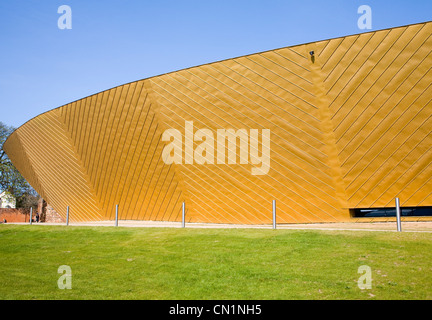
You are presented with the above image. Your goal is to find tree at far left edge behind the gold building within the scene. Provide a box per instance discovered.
[0,121,39,207]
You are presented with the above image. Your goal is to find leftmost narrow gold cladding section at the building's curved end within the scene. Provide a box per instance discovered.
[8,109,103,221]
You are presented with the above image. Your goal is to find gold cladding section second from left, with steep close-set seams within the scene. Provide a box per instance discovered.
[57,81,182,221]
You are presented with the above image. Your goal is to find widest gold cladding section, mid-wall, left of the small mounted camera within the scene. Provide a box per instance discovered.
[151,47,343,223]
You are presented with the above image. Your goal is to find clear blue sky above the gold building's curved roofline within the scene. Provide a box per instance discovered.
[0,0,432,127]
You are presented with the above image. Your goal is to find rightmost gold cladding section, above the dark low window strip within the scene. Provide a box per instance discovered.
[323,23,432,208]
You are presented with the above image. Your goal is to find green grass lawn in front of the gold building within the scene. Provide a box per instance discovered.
[0,224,432,300]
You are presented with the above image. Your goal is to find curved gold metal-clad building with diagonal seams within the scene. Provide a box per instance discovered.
[4,22,432,224]
